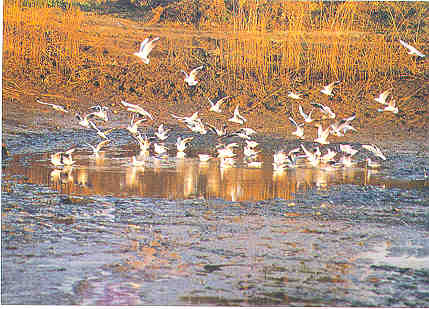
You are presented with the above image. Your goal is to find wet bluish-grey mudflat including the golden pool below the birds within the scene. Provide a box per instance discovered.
[2,127,429,307]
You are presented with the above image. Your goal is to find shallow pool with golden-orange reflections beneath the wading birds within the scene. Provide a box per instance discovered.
[3,148,429,201]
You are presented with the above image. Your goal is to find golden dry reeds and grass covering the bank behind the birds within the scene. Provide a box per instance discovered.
[3,0,428,132]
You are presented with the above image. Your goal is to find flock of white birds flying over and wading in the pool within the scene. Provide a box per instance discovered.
[37,37,425,179]
